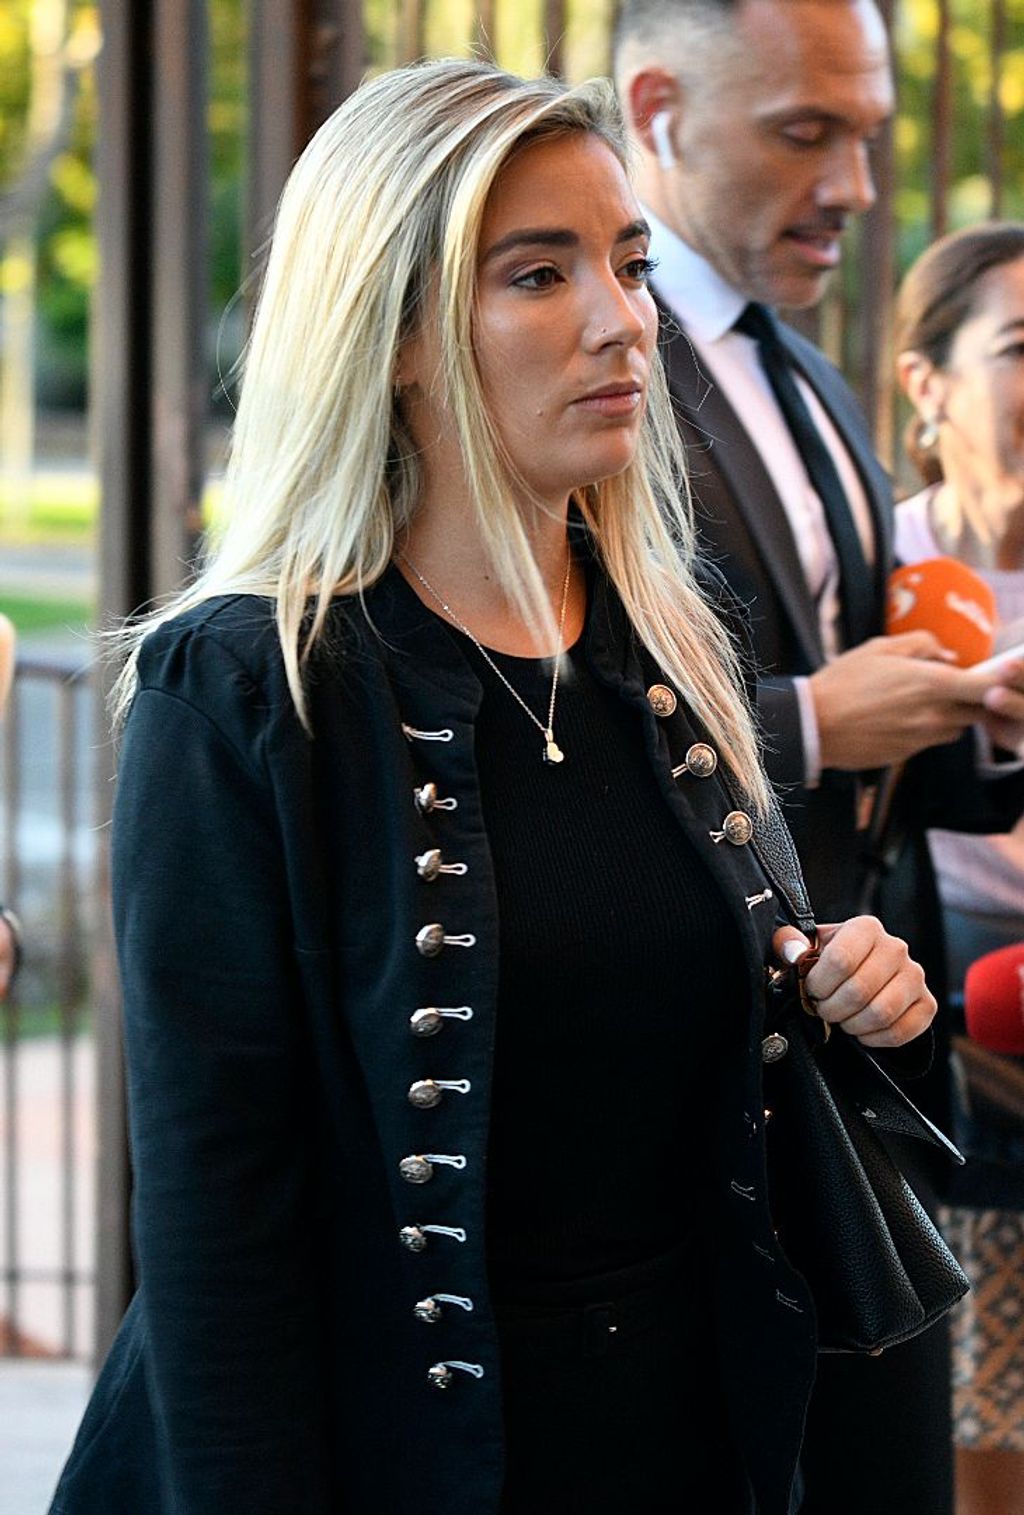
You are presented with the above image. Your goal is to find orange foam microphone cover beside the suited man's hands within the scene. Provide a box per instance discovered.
[885,558,997,668]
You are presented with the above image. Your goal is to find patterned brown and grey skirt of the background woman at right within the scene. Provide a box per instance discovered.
[942,1207,1024,1451]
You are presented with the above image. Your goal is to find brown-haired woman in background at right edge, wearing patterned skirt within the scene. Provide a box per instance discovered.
[897,223,1024,1515]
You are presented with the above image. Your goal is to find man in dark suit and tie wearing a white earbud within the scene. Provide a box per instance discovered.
[615,0,1024,1515]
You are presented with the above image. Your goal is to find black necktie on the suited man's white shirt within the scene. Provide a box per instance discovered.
[733,303,876,647]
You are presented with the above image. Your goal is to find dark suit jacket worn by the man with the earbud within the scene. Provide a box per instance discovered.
[662,311,1024,1030]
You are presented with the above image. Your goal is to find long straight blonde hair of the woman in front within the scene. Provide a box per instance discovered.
[115,59,768,806]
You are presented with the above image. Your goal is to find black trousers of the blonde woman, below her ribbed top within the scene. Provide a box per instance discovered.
[497,1260,753,1515]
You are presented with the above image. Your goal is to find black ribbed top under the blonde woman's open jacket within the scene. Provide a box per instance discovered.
[451,624,747,1297]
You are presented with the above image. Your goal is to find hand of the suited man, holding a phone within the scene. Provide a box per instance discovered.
[807,632,1024,770]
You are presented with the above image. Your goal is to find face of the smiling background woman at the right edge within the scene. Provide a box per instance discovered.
[941,258,1024,482]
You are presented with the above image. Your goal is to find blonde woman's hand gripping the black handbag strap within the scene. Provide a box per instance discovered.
[771,915,938,1047]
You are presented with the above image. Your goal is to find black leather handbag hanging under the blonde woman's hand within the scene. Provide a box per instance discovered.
[765,954,968,1353]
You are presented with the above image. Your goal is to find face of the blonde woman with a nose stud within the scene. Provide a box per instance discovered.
[400,132,657,508]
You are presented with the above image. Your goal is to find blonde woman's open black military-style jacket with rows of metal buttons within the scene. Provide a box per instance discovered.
[53,570,815,1515]
